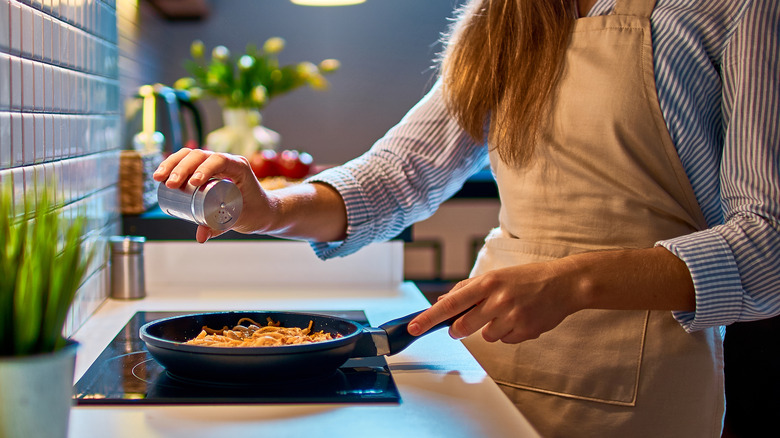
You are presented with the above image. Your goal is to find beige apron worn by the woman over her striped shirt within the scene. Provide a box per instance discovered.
[464,0,725,437]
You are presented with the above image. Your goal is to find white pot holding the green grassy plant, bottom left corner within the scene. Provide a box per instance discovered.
[0,341,78,438]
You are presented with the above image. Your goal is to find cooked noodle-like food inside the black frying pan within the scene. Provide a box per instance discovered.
[185,317,341,347]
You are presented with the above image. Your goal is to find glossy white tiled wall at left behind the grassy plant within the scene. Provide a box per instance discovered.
[0,0,123,332]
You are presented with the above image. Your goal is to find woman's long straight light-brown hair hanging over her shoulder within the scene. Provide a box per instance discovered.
[441,0,575,166]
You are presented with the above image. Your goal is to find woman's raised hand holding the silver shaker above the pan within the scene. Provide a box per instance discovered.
[153,148,272,243]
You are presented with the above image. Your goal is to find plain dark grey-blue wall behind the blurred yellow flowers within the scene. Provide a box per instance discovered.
[140,0,459,163]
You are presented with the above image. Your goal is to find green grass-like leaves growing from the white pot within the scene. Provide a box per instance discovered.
[0,183,93,356]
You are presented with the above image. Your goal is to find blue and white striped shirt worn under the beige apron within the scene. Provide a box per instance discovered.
[311,0,780,331]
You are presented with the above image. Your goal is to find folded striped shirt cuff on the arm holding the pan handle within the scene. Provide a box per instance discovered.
[656,229,744,333]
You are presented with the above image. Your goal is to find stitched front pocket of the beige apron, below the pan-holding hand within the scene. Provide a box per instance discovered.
[463,310,649,406]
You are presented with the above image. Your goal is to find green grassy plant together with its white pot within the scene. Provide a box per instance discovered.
[0,183,91,437]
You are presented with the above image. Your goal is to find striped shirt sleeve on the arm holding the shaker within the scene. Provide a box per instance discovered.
[308,82,488,259]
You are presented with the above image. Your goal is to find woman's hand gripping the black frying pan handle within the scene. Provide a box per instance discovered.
[409,262,579,344]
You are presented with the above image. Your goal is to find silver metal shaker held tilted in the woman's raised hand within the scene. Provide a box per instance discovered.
[157,179,244,230]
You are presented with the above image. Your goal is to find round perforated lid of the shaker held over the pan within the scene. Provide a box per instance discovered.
[192,179,244,230]
